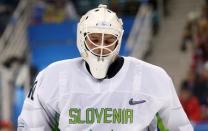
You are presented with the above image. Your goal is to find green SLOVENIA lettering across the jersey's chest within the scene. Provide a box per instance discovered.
[68,108,134,124]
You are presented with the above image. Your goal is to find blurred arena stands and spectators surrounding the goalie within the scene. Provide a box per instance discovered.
[0,0,208,131]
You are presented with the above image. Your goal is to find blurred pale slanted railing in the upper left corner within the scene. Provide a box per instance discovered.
[0,0,31,63]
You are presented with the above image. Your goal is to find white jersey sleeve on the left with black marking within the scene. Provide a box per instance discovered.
[17,71,56,131]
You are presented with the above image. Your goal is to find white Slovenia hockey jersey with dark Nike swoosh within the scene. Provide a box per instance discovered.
[18,57,193,131]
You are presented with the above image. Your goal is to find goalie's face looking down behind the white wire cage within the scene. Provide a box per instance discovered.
[85,33,118,57]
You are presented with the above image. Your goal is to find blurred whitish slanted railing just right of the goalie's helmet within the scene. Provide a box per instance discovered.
[126,5,152,59]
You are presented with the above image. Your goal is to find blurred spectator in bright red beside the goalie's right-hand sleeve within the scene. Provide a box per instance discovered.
[180,85,201,122]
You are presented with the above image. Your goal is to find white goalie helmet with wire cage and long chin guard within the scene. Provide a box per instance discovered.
[77,4,123,79]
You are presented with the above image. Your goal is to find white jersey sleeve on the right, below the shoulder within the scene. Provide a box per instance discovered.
[159,77,193,131]
